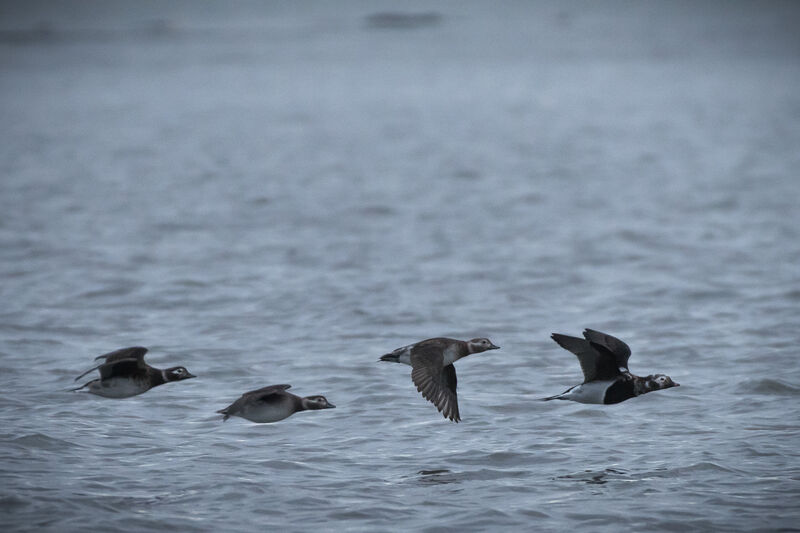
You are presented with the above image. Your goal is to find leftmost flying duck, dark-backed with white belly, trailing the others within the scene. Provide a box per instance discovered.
[72,346,196,398]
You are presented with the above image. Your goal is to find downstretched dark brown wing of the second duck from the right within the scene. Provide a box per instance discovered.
[411,350,461,422]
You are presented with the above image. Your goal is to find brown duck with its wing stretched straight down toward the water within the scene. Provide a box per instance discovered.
[380,337,500,422]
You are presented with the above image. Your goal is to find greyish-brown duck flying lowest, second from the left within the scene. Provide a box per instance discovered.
[217,385,336,423]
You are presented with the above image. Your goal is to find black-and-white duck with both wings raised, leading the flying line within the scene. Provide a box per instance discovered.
[542,329,679,404]
